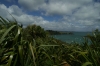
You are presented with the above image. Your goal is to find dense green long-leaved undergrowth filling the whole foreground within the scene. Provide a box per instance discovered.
[0,17,100,66]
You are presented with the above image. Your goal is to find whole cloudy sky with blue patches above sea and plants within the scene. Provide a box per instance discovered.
[0,0,100,31]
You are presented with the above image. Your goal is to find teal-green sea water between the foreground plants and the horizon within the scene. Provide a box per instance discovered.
[53,32,92,43]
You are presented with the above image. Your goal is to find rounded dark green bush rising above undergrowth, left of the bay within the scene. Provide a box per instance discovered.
[23,25,47,39]
